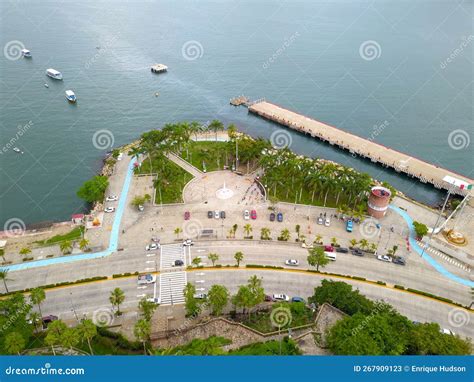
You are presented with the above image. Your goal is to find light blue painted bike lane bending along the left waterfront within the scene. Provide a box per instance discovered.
[0,159,135,272]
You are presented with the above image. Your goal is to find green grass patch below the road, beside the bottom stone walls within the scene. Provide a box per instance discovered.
[242,302,314,333]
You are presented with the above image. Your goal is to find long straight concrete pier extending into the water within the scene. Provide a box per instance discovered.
[248,101,474,200]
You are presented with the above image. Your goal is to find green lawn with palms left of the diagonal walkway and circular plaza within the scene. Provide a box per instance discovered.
[135,157,193,204]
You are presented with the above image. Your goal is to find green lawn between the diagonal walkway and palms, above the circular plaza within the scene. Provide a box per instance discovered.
[181,141,235,172]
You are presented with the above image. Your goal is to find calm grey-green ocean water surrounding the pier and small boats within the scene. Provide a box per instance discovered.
[0,0,474,230]
